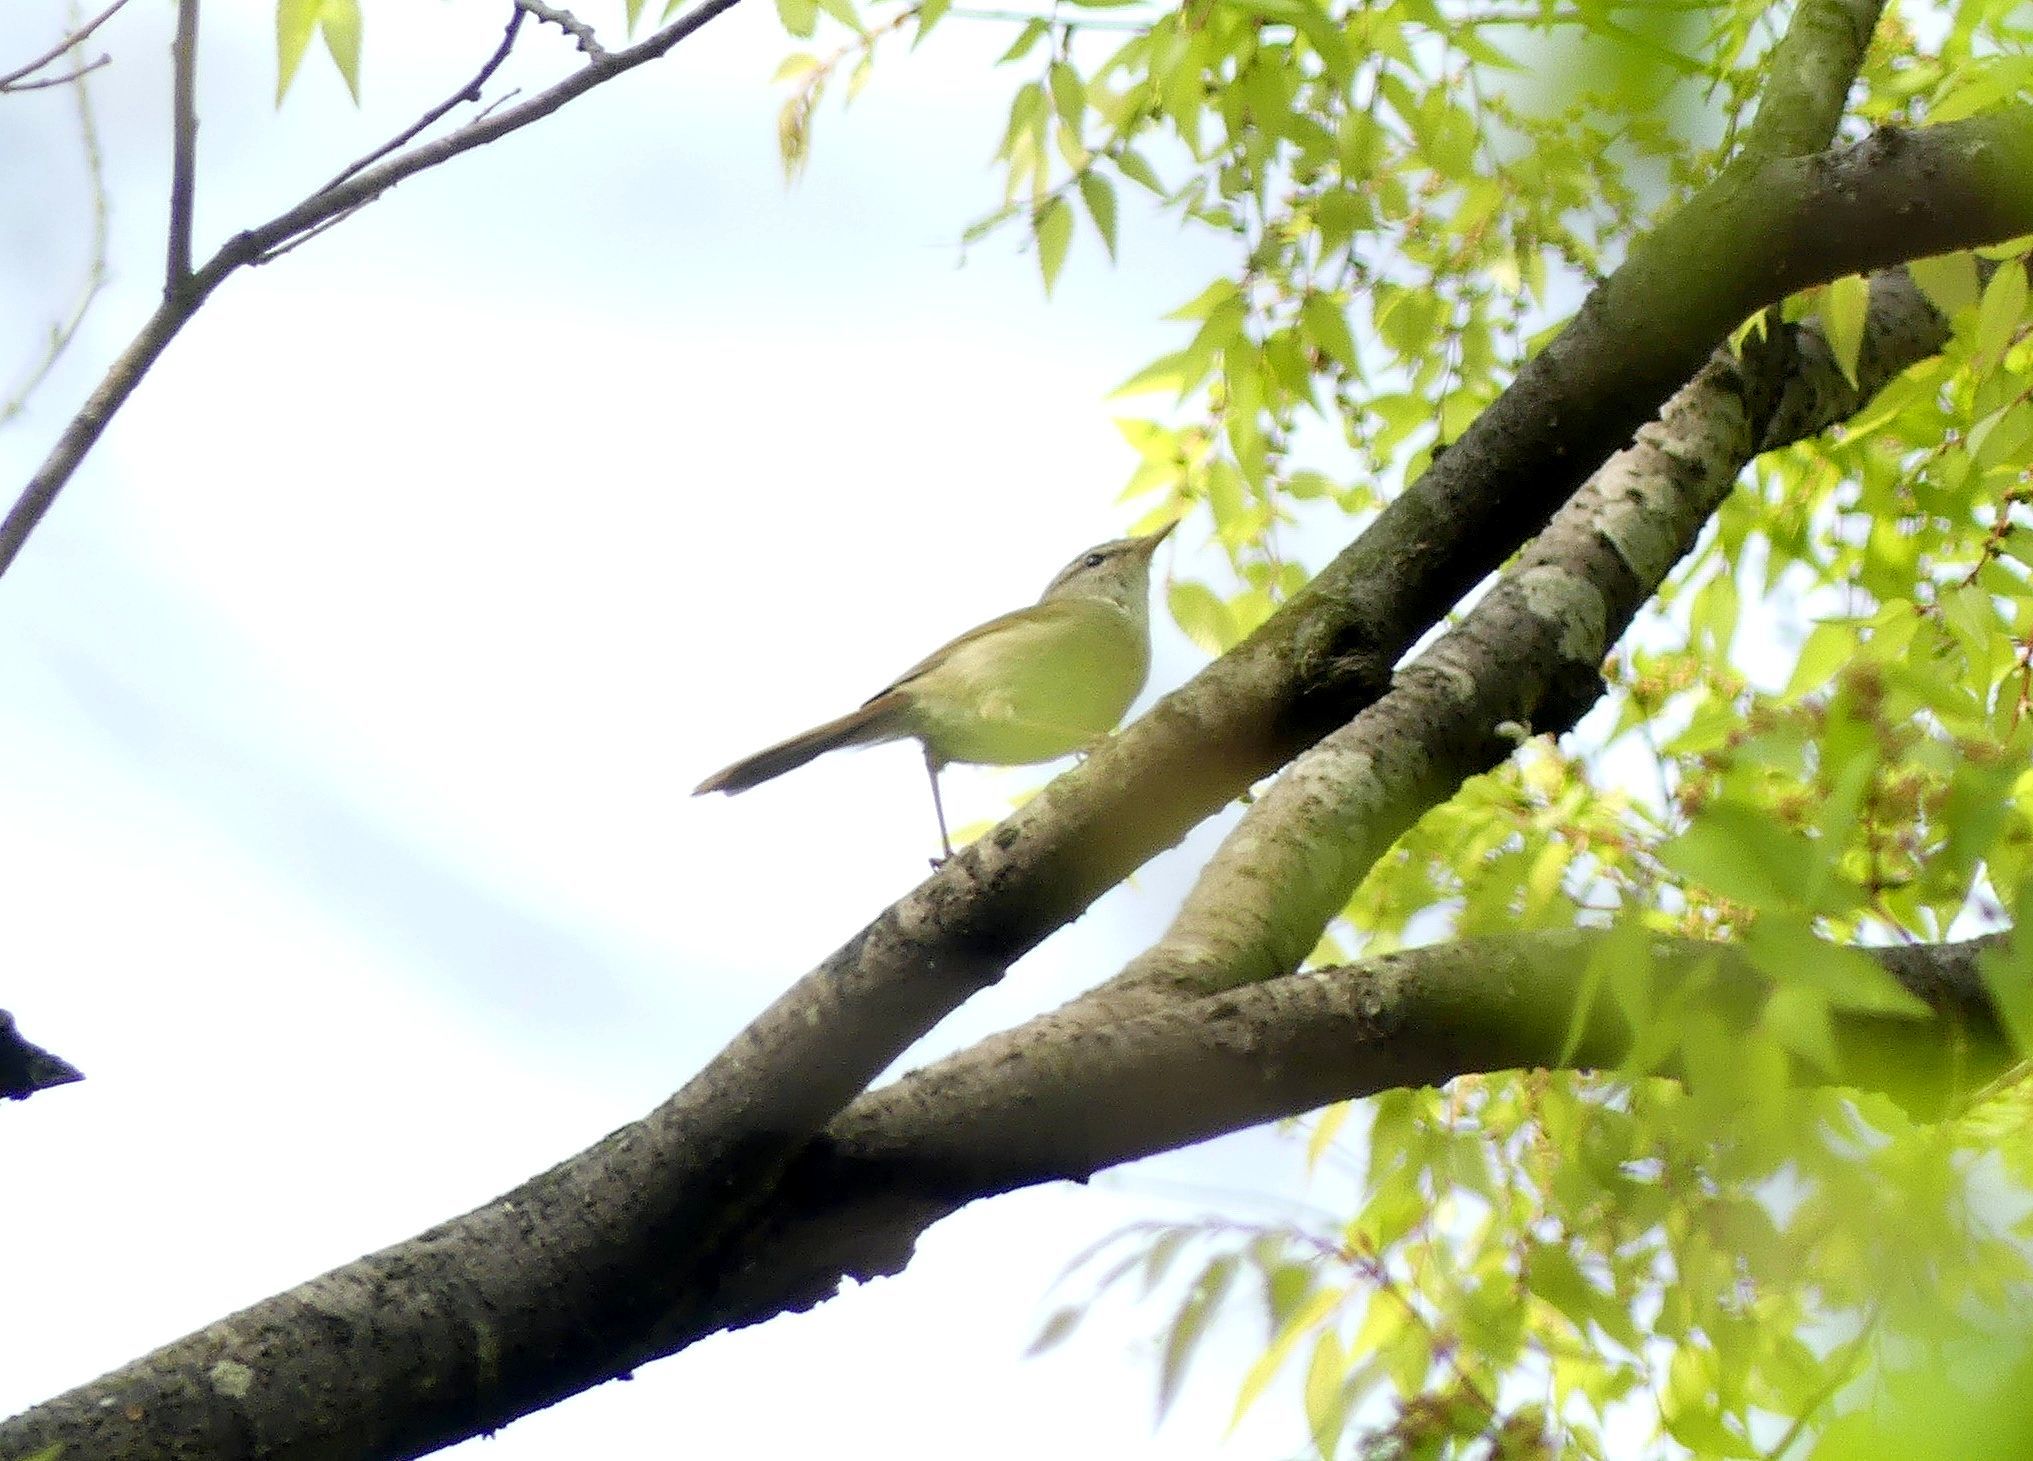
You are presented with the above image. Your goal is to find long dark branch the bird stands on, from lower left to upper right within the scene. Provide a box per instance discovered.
[0,14,2033,1457]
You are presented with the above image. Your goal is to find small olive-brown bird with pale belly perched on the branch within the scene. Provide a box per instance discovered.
[691,522,1177,857]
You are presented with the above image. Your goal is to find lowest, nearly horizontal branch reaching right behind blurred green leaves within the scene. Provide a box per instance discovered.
[548,933,2013,1347]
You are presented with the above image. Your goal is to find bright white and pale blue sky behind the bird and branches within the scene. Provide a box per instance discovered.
[0,0,1366,1461]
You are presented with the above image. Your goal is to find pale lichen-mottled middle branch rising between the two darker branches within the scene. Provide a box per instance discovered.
[1102,270,1942,1015]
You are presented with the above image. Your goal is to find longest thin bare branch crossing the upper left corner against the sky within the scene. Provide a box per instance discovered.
[0,0,740,573]
